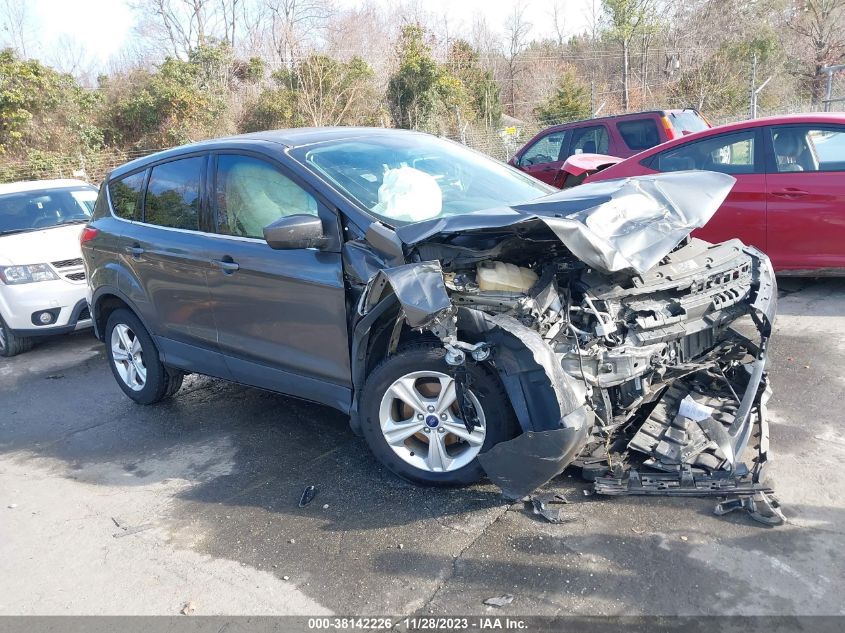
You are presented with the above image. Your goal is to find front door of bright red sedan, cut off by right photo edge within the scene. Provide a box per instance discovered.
[766,124,845,270]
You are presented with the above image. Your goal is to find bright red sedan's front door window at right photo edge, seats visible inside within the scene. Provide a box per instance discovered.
[771,126,845,172]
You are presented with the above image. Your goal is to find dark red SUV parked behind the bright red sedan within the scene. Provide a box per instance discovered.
[509,109,710,187]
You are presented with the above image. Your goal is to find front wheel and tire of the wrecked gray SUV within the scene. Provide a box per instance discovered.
[361,343,518,486]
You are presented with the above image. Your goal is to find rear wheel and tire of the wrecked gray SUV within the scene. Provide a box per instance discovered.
[105,309,184,404]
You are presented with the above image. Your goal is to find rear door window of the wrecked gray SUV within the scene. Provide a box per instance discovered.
[144,156,205,231]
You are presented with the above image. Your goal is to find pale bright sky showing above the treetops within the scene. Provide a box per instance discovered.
[9,0,598,68]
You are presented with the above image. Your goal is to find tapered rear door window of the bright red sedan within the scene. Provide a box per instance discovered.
[654,130,759,174]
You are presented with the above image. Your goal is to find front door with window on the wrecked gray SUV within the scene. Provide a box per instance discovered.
[208,152,351,409]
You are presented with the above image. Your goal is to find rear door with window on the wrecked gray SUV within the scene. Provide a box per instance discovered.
[117,154,229,378]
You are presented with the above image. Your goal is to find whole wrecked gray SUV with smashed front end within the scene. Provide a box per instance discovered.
[82,128,776,509]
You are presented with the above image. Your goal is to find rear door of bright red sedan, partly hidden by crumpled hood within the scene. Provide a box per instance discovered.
[648,128,767,251]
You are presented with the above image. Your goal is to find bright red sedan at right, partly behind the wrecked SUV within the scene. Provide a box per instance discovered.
[580,113,845,276]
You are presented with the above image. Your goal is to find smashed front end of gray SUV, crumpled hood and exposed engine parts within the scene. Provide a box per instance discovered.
[344,173,782,522]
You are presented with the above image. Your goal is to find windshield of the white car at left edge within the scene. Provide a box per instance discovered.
[0,187,97,235]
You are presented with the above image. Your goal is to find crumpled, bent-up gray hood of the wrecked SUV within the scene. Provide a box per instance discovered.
[396,171,736,274]
